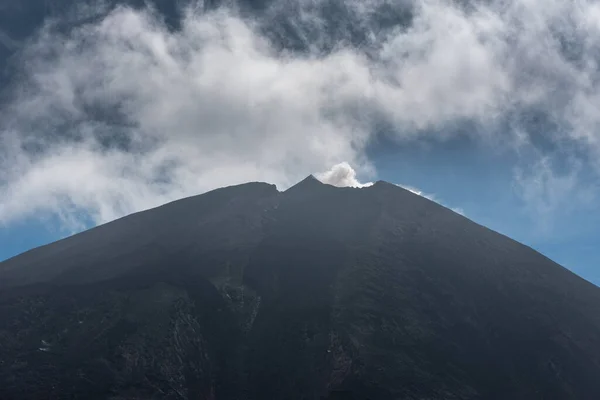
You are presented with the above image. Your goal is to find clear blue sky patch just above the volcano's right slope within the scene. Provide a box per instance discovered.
[370,138,600,284]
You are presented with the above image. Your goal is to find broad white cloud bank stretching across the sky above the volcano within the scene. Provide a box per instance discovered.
[0,0,600,228]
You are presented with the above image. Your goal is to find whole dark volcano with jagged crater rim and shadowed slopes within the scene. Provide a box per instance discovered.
[0,177,600,400]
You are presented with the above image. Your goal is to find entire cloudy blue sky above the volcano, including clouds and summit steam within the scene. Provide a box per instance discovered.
[0,0,600,284]
